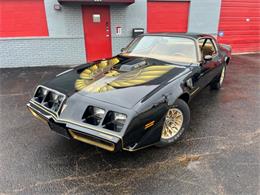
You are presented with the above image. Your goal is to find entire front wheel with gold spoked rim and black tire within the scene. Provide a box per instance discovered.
[157,99,190,147]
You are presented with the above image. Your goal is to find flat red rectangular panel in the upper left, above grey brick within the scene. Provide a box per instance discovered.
[0,0,48,37]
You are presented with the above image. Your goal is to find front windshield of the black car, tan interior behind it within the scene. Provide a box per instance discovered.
[123,36,197,63]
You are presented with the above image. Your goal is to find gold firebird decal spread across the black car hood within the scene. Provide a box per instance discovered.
[75,58,175,93]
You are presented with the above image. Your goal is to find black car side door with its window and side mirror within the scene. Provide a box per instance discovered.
[195,38,221,88]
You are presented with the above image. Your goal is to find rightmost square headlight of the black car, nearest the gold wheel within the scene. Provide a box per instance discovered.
[103,111,127,132]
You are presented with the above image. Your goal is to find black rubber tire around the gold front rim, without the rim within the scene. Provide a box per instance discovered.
[156,99,190,147]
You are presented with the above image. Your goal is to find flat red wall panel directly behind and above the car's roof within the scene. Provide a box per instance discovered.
[147,1,190,32]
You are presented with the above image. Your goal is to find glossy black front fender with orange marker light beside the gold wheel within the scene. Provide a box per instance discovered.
[123,71,187,151]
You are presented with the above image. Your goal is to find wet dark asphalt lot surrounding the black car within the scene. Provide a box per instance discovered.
[0,54,260,194]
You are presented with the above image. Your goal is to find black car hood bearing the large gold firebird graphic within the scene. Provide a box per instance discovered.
[44,58,188,109]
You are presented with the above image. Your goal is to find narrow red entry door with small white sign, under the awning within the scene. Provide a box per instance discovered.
[82,5,112,62]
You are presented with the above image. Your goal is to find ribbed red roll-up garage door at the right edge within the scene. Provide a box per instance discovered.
[218,0,260,53]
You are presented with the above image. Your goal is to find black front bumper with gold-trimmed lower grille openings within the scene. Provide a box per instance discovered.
[27,101,122,152]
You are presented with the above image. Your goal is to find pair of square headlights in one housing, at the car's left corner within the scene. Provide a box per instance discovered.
[33,86,65,113]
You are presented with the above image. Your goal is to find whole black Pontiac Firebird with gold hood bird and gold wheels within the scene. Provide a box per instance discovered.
[27,33,231,151]
